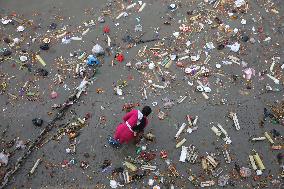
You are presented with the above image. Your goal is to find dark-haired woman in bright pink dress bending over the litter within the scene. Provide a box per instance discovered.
[109,106,152,147]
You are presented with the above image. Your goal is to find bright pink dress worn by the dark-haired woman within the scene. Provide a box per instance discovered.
[114,110,148,144]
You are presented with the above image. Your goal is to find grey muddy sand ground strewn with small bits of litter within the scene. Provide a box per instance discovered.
[0,0,284,188]
